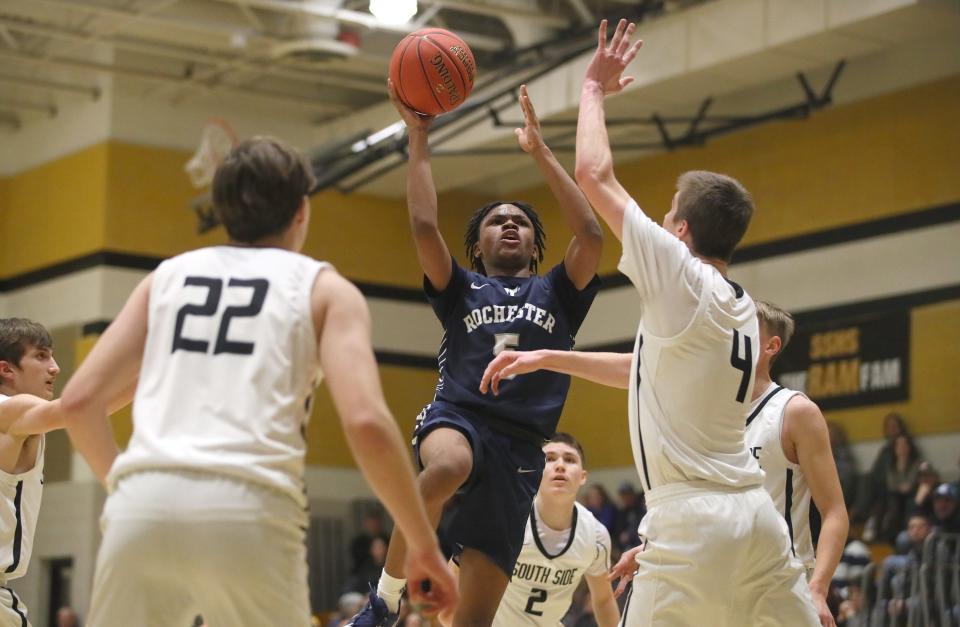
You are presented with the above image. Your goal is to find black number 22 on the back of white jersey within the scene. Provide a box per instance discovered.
[170,276,270,355]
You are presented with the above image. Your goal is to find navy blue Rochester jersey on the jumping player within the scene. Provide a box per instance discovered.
[424,261,600,438]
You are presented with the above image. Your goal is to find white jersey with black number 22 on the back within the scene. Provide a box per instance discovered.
[108,246,327,506]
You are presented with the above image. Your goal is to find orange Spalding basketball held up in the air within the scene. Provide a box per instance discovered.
[390,28,477,115]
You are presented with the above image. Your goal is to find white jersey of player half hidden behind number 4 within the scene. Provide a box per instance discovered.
[747,383,814,570]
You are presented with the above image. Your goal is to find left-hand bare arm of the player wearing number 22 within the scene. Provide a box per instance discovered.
[60,275,153,483]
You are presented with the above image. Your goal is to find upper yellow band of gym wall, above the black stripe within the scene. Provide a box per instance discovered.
[0,76,960,287]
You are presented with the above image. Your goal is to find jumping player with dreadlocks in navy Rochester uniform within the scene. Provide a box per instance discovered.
[349,86,603,627]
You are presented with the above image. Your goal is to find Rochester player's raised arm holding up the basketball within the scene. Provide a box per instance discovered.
[387,81,453,292]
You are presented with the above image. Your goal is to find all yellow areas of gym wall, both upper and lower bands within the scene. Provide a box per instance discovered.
[7,71,960,467]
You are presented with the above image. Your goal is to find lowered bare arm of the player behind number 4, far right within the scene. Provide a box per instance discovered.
[784,396,850,627]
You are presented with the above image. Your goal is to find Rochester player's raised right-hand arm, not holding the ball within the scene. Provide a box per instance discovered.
[514,85,603,290]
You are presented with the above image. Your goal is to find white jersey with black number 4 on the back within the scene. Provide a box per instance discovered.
[619,200,763,490]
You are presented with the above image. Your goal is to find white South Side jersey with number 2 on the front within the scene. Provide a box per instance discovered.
[493,503,610,627]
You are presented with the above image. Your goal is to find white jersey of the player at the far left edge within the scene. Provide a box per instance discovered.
[0,394,46,581]
